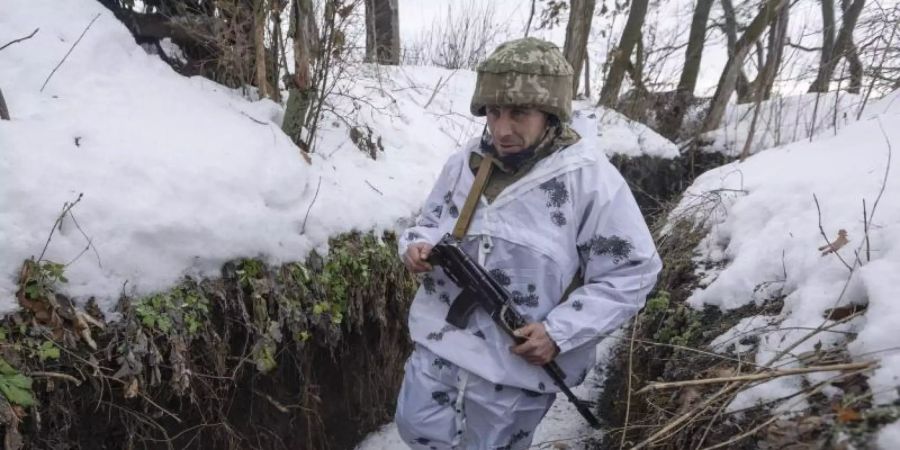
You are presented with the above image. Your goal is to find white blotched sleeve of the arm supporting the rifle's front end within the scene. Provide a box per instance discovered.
[544,182,662,352]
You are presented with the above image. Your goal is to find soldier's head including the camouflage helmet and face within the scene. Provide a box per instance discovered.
[470,38,573,154]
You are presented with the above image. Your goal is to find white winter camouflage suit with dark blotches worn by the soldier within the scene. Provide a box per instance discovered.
[396,133,661,449]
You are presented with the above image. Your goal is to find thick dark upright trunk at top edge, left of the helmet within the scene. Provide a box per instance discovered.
[366,0,400,65]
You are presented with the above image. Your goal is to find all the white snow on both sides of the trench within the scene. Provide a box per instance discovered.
[0,0,900,449]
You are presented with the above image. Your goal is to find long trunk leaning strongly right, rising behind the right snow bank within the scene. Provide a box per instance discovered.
[701,0,788,132]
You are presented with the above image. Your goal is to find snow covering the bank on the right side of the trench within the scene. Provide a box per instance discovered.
[670,80,900,440]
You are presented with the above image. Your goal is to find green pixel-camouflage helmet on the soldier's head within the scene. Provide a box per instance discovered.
[470,37,573,122]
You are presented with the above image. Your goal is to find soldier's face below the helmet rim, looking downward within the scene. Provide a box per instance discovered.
[485,106,547,155]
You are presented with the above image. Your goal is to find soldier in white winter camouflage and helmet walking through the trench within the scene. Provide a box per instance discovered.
[396,38,661,449]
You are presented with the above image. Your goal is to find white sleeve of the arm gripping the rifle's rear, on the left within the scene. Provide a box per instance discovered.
[397,155,459,260]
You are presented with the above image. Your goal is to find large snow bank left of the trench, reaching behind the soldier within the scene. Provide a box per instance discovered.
[0,0,663,314]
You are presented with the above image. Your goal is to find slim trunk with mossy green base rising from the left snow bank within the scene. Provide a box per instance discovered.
[281,0,319,150]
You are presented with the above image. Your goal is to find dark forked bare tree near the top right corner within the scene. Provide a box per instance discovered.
[809,0,866,93]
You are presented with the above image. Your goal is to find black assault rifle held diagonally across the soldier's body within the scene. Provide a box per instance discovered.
[428,234,600,428]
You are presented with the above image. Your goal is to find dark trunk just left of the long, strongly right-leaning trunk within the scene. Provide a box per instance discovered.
[659,0,713,139]
